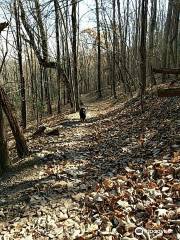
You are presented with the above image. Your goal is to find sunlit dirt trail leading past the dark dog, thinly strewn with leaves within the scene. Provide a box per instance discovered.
[0,97,121,236]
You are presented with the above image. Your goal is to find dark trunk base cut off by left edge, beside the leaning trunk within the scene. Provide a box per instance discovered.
[0,104,9,172]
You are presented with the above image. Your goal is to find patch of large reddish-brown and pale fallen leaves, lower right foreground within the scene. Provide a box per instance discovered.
[83,156,180,239]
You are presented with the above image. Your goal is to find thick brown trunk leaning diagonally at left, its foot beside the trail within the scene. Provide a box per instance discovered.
[0,87,28,158]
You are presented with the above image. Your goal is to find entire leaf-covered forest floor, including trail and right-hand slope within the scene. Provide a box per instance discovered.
[0,91,180,240]
